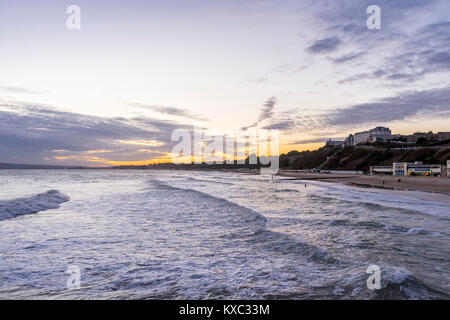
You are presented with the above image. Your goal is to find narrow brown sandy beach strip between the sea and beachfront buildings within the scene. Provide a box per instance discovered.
[278,172,450,196]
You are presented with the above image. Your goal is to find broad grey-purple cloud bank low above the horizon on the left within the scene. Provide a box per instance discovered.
[0,103,191,165]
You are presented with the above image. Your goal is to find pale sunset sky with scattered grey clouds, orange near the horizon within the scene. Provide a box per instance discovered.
[0,0,450,165]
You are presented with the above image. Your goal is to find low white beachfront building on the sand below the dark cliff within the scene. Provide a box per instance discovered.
[370,161,442,177]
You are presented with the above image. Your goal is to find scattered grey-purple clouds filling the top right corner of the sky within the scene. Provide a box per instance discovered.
[296,0,450,88]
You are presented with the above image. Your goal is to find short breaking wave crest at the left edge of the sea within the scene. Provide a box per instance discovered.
[0,190,70,221]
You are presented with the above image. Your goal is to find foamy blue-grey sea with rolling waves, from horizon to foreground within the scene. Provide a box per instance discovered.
[0,169,450,299]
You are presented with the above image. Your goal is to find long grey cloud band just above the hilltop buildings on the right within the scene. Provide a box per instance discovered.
[256,88,450,144]
